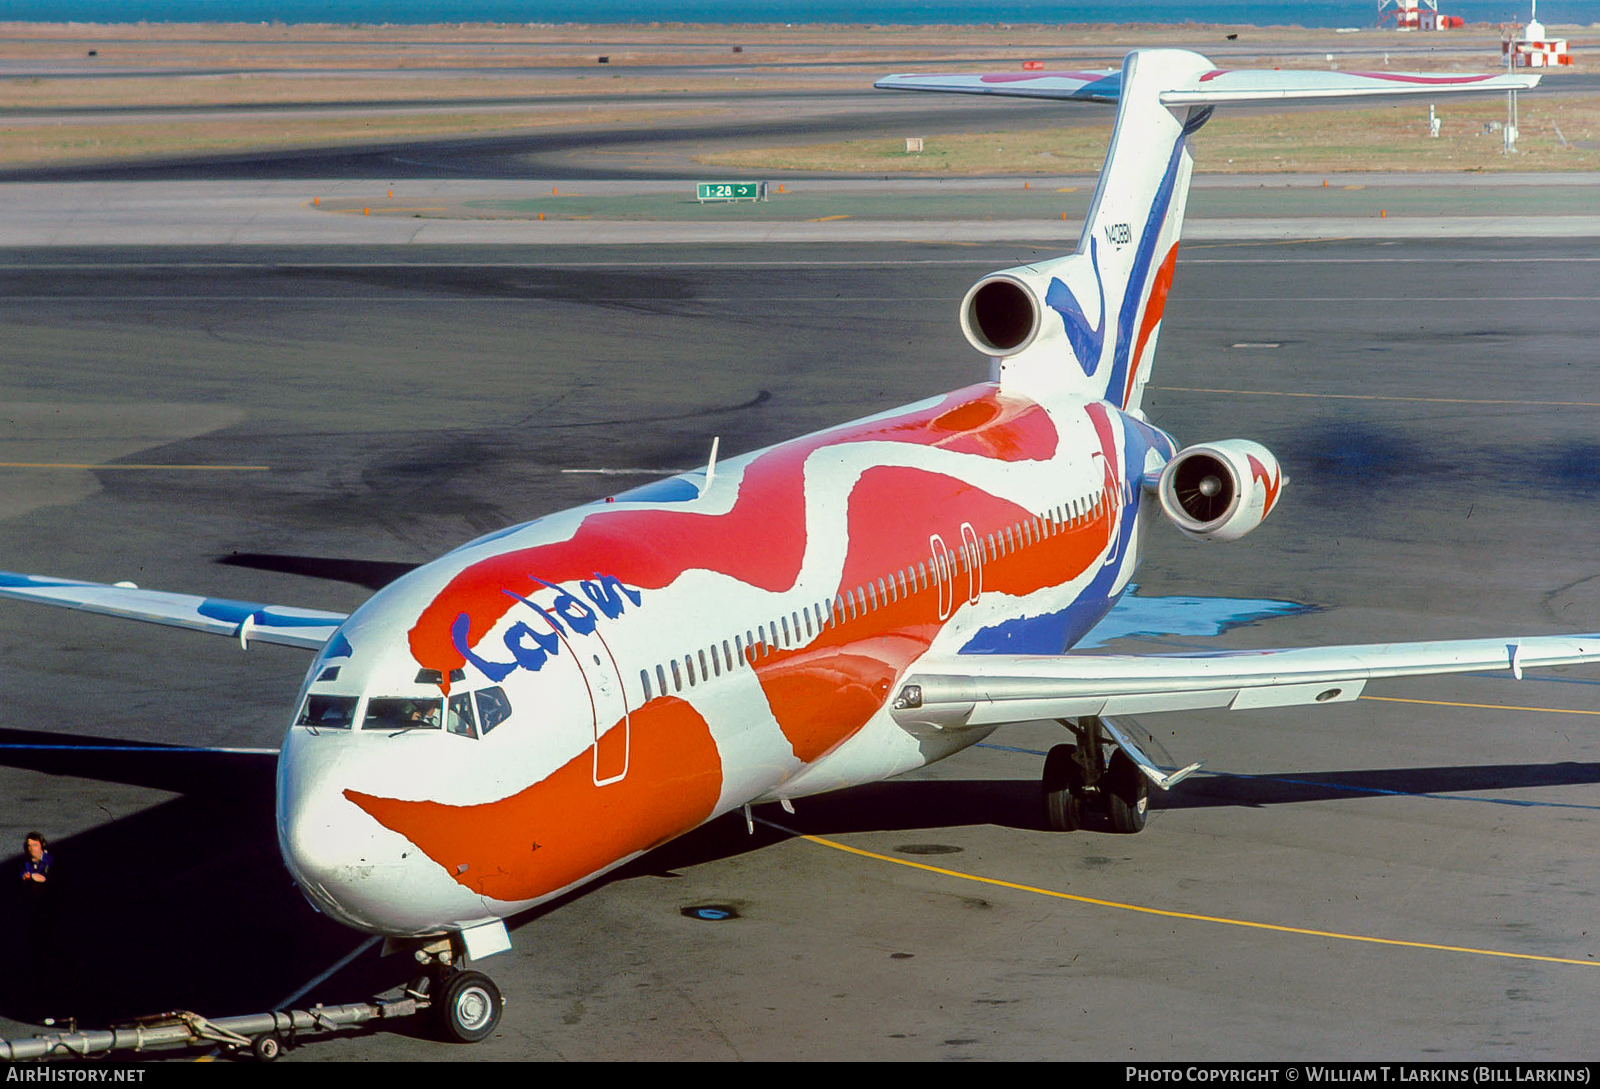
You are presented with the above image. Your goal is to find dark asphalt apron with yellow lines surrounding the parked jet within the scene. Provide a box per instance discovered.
[0,219,1600,1060]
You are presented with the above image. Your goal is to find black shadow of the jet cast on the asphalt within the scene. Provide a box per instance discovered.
[0,729,1600,1031]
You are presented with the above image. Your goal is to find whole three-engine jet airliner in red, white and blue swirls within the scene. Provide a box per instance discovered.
[0,50,1574,1039]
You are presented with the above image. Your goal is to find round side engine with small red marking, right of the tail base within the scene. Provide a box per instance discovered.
[1158,438,1288,541]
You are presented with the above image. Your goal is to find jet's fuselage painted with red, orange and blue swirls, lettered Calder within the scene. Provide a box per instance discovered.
[278,384,1174,935]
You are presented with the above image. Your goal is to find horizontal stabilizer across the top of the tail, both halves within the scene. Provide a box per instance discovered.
[872,69,1539,106]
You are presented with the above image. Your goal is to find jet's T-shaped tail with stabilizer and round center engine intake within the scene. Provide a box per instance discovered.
[877,50,1539,409]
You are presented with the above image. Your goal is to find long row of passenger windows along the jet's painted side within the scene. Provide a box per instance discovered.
[638,493,1104,702]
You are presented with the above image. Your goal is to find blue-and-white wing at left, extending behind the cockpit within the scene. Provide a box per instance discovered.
[0,571,346,651]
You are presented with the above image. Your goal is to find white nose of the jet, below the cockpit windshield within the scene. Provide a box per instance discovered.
[277,729,485,937]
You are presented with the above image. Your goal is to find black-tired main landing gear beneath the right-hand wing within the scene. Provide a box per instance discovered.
[1042,715,1150,833]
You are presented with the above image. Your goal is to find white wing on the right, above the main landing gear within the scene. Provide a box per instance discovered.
[891,635,1600,729]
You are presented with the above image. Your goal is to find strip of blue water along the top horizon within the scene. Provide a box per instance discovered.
[12,0,1600,27]
